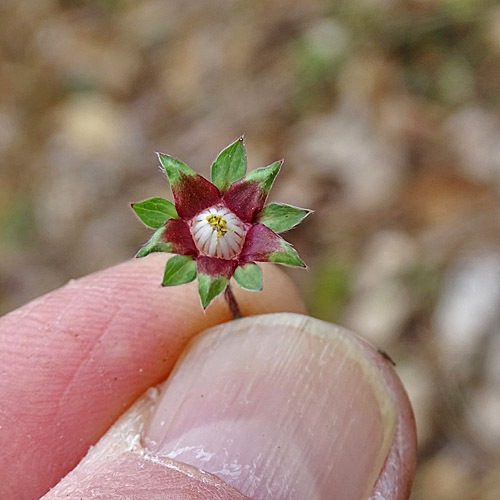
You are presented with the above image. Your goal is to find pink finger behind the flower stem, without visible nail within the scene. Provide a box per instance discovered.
[0,256,303,499]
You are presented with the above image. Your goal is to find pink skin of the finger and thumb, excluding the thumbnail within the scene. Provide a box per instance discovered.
[0,255,416,500]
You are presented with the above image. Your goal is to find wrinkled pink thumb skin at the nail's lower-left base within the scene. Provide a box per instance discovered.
[41,389,247,500]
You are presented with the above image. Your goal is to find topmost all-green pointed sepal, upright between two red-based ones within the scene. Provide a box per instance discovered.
[211,137,247,192]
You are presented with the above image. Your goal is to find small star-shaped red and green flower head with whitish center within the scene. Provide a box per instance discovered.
[132,138,310,308]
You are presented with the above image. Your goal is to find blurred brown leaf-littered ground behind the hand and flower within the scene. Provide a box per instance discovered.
[0,0,500,500]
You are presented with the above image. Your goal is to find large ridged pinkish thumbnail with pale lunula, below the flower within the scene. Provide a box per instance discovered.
[143,314,396,500]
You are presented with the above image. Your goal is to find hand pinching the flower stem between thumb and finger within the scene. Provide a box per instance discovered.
[0,255,415,500]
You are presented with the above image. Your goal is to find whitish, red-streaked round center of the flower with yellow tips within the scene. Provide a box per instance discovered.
[189,204,248,259]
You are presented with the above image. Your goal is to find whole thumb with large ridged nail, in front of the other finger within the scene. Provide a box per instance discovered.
[44,314,416,500]
